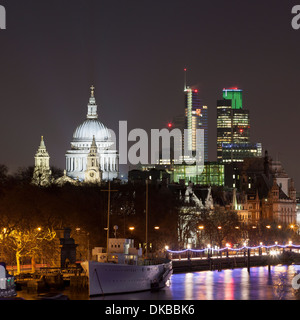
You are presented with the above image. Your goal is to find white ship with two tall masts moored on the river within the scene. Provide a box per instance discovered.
[81,181,173,296]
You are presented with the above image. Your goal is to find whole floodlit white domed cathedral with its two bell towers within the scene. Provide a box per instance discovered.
[32,87,119,186]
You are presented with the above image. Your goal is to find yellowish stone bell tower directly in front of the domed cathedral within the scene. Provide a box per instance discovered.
[84,136,102,183]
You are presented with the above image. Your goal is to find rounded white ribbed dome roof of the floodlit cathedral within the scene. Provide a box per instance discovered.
[73,119,111,142]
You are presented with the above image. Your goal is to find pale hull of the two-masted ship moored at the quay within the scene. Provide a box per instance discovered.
[82,261,172,296]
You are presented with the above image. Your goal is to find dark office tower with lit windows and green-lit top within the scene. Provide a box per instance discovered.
[217,88,262,163]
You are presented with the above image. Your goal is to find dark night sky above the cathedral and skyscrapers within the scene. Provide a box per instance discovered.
[0,0,300,189]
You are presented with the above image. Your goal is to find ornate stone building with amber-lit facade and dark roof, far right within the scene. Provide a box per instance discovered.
[229,151,297,226]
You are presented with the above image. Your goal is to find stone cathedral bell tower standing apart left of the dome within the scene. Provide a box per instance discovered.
[32,137,52,187]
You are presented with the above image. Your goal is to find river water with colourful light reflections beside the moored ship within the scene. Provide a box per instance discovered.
[18,265,300,300]
